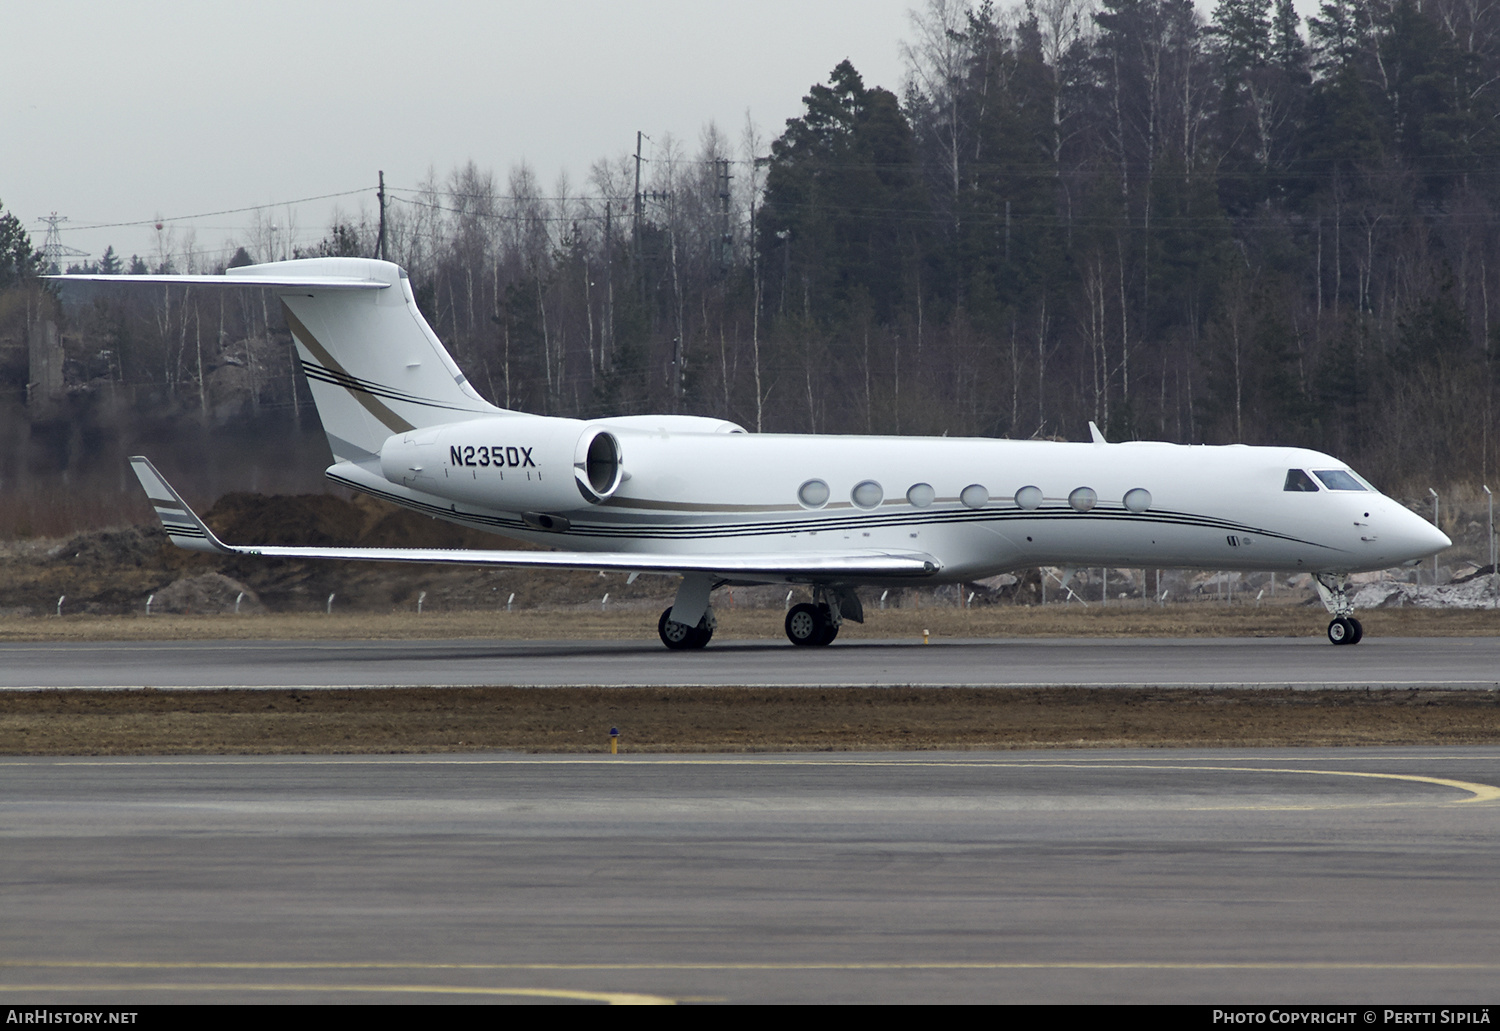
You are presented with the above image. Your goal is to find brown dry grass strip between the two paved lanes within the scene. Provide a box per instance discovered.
[0,687,1500,755]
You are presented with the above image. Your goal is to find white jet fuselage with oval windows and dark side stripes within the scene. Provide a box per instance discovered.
[348,416,1449,582]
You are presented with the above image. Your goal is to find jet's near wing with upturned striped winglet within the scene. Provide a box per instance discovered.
[131,456,942,582]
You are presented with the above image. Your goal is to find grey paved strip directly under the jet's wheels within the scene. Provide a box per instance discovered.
[0,636,1500,689]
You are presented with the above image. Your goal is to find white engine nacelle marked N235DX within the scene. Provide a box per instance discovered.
[380,416,624,513]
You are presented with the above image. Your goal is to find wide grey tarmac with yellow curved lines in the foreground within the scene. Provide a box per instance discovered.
[0,749,1500,1005]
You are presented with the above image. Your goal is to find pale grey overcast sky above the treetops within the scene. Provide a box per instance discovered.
[0,0,914,265]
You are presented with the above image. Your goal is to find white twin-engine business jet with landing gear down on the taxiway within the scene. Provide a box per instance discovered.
[52,258,1451,648]
